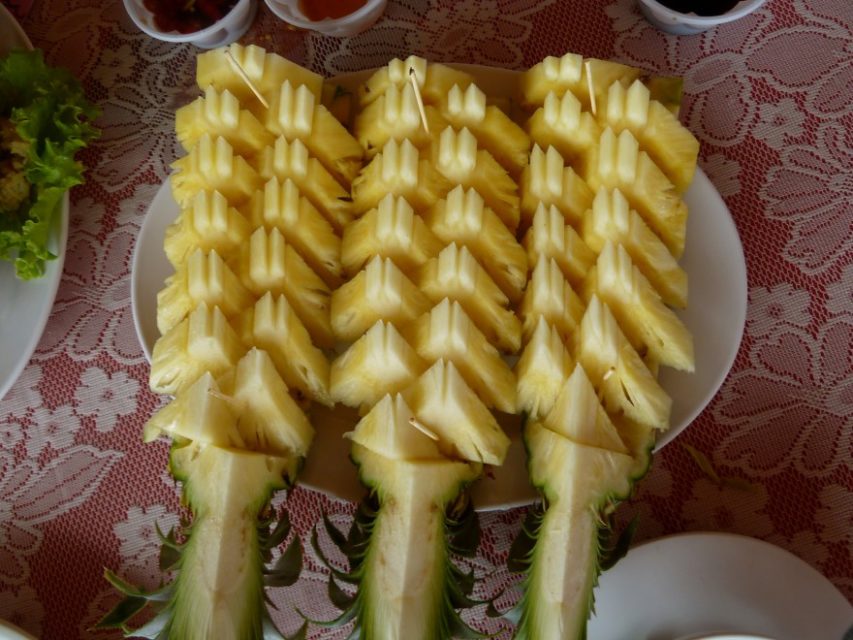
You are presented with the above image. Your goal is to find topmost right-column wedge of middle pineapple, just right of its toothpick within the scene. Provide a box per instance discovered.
[430,84,531,176]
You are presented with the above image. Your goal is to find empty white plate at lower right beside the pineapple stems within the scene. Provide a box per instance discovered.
[588,533,853,640]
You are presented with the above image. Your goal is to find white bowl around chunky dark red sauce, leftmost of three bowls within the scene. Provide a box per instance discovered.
[124,0,258,49]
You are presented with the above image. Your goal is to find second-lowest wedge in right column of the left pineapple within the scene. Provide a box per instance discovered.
[232,291,333,407]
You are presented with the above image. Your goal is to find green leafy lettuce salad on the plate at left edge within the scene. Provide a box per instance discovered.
[0,51,98,280]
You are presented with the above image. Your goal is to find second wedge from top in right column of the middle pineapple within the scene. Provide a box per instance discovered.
[433,127,519,233]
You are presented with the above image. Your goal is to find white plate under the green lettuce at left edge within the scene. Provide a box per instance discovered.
[0,5,68,398]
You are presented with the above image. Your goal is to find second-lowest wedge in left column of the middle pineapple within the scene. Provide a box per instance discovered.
[331,320,427,407]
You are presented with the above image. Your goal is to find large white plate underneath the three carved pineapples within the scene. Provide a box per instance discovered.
[131,65,747,509]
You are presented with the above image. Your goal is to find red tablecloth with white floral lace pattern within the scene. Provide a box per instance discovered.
[0,0,853,638]
